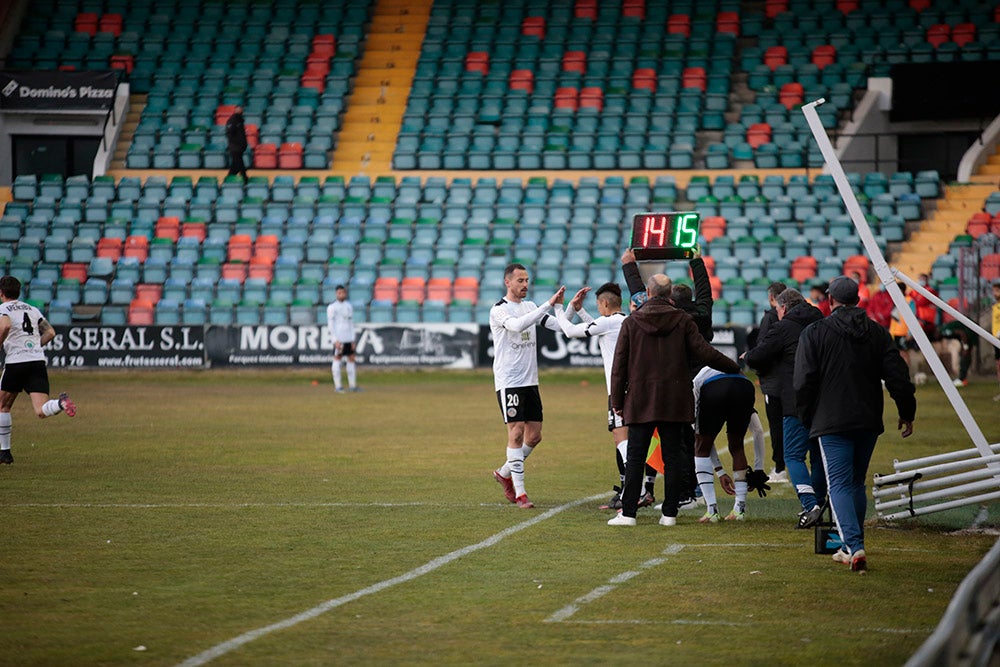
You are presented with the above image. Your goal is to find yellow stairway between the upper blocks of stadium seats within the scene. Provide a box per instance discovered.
[333,0,432,173]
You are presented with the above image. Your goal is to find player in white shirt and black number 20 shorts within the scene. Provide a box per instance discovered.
[490,264,566,508]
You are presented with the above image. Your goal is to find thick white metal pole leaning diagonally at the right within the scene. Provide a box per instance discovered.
[802,98,1000,479]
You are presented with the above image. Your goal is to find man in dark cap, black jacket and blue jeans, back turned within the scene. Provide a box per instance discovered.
[794,276,917,574]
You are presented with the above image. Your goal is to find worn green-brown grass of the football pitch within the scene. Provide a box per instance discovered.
[0,368,1000,665]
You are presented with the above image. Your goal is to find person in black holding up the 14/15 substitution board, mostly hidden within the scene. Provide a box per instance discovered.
[622,250,715,509]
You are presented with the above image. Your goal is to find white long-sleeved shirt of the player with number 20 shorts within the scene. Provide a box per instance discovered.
[490,299,562,391]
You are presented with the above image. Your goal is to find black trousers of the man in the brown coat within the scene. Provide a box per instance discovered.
[622,422,693,518]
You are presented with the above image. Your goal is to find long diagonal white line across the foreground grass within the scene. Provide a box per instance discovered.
[180,493,606,667]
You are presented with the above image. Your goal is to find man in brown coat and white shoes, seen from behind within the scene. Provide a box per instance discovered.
[608,273,740,526]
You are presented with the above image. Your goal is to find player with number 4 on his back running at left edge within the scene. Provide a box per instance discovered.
[0,276,76,464]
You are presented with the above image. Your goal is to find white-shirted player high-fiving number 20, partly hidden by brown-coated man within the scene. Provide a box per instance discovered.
[557,283,656,509]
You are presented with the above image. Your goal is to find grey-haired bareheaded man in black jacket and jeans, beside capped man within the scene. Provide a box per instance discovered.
[743,288,826,528]
